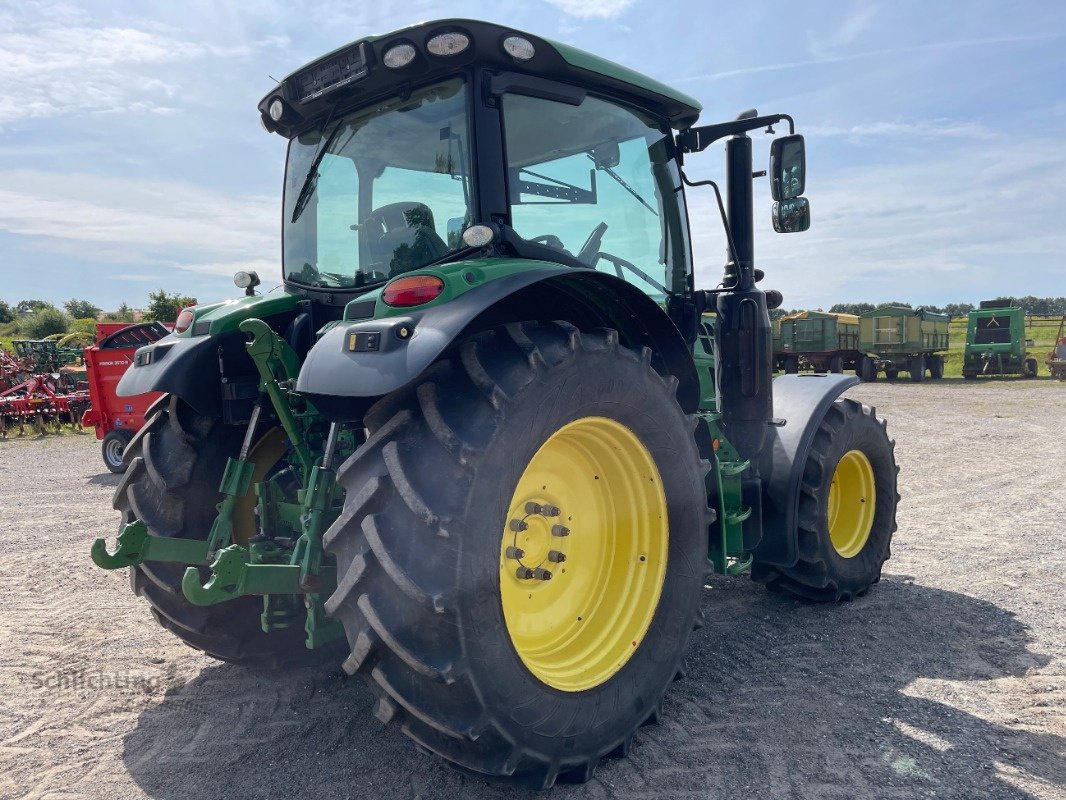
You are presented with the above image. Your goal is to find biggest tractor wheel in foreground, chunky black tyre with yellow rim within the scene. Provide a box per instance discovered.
[324,323,709,787]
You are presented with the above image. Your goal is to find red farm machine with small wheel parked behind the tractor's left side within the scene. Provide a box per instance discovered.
[81,322,171,473]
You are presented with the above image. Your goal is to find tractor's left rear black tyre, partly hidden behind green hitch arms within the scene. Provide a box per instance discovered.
[114,397,336,668]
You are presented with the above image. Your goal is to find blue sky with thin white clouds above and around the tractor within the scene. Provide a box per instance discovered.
[0,0,1066,308]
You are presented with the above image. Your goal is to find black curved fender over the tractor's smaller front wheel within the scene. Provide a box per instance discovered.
[754,373,859,566]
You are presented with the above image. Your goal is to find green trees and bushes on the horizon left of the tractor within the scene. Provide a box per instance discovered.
[0,289,196,339]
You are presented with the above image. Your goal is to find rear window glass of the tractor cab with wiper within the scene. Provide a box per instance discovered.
[282,79,472,288]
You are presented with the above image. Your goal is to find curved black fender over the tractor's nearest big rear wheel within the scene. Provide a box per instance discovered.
[296,269,699,416]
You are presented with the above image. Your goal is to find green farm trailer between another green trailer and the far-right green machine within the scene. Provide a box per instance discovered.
[856,306,950,382]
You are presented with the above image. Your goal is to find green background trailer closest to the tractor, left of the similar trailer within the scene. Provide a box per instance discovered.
[774,311,862,374]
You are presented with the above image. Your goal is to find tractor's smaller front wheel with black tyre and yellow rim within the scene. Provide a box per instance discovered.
[752,399,900,602]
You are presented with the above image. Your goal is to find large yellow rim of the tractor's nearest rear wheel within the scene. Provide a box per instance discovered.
[500,417,668,691]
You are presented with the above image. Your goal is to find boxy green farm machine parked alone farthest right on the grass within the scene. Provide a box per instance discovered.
[963,301,1037,381]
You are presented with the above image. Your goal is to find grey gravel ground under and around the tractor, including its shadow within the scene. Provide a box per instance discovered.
[0,381,1066,800]
